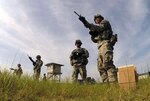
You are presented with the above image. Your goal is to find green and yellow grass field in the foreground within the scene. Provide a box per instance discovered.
[0,72,150,101]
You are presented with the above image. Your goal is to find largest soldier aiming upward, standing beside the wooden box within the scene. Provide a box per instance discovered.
[79,14,117,82]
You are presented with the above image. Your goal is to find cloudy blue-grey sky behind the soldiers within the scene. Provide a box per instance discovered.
[0,0,150,80]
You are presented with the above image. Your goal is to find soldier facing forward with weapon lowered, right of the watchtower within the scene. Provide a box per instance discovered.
[70,40,89,81]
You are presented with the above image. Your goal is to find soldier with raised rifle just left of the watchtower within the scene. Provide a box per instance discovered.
[29,55,43,80]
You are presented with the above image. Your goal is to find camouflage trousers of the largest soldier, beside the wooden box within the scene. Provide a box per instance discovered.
[98,41,117,82]
